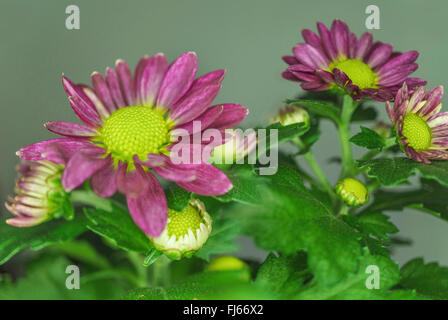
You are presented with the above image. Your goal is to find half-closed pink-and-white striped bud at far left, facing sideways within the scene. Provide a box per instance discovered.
[5,160,73,227]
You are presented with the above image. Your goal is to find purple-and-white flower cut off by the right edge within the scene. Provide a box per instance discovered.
[386,83,448,163]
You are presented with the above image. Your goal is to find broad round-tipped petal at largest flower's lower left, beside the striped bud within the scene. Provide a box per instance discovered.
[62,146,110,191]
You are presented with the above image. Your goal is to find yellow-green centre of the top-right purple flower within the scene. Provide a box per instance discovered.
[329,59,378,90]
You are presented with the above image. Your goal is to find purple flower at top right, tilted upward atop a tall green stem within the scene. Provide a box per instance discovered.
[282,20,426,101]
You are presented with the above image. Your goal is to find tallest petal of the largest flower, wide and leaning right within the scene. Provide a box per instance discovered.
[157,52,198,108]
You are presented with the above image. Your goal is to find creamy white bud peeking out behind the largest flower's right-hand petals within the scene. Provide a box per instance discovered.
[209,129,257,164]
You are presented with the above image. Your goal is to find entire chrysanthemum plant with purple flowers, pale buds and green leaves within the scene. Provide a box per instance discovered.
[0,20,448,299]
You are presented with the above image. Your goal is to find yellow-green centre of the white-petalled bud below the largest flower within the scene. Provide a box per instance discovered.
[167,204,205,239]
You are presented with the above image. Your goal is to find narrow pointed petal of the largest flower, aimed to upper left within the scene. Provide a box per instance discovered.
[62,76,101,127]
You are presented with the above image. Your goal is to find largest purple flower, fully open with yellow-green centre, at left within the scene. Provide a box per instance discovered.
[18,52,248,237]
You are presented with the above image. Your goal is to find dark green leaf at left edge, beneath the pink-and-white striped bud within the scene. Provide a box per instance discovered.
[0,215,87,264]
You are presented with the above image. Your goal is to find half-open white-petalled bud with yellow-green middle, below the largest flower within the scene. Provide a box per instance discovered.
[151,199,212,260]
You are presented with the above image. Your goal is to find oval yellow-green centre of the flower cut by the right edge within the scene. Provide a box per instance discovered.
[403,113,432,151]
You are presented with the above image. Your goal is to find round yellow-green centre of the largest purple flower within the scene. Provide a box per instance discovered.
[101,106,170,162]
